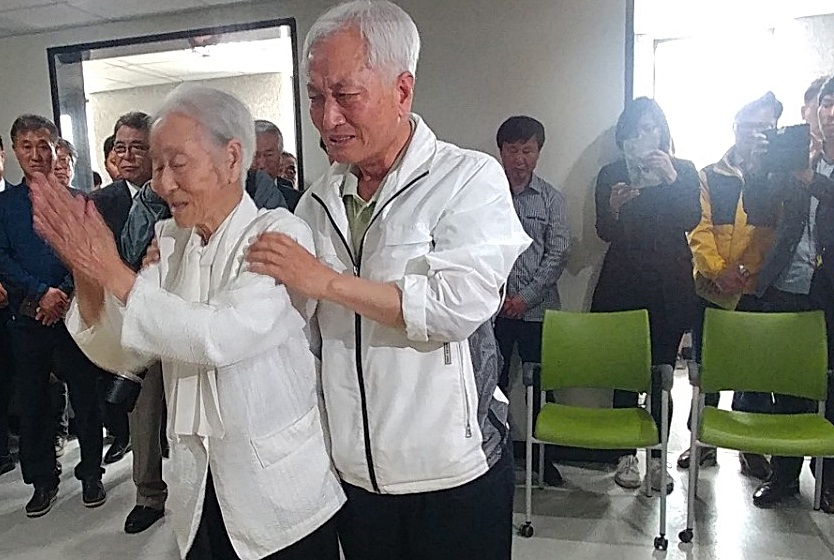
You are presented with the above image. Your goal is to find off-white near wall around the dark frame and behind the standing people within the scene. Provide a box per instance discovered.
[0,0,625,309]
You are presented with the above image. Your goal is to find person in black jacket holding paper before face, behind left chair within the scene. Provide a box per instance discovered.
[591,97,701,492]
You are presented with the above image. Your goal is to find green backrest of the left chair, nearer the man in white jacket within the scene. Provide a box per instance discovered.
[542,309,651,393]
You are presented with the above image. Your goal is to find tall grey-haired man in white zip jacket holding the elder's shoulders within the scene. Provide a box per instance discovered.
[248,0,530,560]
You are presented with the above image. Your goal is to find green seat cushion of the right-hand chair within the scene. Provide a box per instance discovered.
[699,406,834,457]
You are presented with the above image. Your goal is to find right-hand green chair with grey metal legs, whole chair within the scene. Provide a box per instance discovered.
[678,309,834,542]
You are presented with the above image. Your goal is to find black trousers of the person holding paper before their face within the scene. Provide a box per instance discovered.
[613,306,686,457]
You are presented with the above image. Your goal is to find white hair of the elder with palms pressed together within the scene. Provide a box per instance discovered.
[154,84,255,187]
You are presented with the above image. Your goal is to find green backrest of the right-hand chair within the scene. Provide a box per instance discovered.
[701,309,828,401]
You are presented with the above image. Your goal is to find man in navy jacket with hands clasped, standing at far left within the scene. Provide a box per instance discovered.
[0,115,107,517]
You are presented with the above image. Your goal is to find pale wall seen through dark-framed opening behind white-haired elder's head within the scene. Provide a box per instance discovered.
[87,73,295,177]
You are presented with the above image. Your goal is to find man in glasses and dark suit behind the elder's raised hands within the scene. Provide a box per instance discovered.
[90,112,168,533]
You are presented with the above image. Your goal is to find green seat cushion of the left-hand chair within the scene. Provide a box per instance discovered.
[535,403,660,449]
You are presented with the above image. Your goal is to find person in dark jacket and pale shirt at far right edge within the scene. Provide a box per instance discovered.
[744,80,834,513]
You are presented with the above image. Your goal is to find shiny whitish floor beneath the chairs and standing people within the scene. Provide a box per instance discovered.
[0,372,834,560]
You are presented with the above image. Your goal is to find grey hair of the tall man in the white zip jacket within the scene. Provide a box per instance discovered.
[302,0,420,78]
